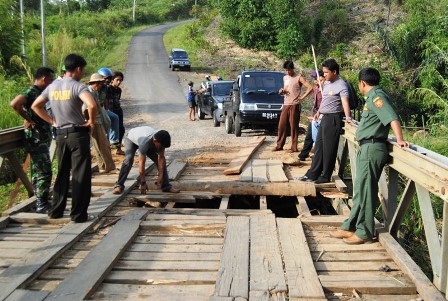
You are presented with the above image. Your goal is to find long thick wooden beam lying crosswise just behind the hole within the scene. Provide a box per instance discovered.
[148,181,316,196]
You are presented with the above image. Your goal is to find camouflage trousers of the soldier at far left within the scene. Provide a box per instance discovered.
[25,139,52,201]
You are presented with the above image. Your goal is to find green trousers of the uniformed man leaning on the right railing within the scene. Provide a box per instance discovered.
[341,142,389,239]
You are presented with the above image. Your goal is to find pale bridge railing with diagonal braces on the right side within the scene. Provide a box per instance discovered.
[337,124,448,293]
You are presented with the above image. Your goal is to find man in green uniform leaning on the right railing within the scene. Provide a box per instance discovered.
[330,68,409,244]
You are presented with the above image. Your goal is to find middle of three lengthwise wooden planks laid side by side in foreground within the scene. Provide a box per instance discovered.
[250,214,287,294]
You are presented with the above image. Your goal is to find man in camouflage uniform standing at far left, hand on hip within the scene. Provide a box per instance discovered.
[11,67,54,213]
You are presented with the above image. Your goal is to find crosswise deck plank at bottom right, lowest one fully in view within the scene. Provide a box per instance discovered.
[319,273,416,295]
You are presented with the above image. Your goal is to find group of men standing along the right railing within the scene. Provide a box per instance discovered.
[273,59,410,244]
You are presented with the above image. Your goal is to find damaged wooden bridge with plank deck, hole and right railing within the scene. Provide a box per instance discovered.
[0,126,448,301]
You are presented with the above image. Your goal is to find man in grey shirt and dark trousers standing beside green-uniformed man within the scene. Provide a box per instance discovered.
[299,59,351,184]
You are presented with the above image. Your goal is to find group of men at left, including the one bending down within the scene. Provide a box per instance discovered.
[11,54,178,223]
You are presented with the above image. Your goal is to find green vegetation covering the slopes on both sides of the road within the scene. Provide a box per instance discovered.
[0,0,448,278]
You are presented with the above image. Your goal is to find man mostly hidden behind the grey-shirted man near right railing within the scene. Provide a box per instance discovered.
[299,70,325,161]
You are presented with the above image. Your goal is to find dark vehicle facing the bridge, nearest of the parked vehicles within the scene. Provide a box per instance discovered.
[223,70,284,137]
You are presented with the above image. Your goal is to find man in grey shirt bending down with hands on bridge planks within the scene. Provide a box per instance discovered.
[113,126,179,194]
